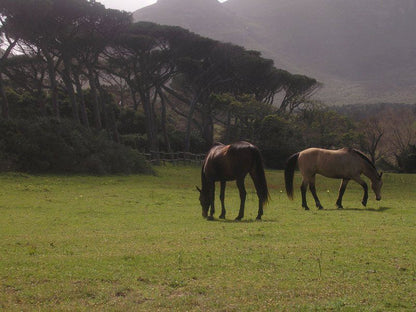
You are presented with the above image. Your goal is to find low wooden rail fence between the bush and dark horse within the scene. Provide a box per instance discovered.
[141,151,205,164]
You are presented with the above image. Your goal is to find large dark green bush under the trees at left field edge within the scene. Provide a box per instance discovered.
[0,119,152,174]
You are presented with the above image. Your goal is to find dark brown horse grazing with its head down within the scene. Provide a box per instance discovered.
[197,141,269,220]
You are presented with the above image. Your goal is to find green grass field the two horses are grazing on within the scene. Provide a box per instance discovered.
[0,166,416,311]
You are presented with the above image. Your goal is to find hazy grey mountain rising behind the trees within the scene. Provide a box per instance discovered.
[133,0,416,104]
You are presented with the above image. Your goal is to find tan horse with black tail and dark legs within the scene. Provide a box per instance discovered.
[285,148,383,210]
